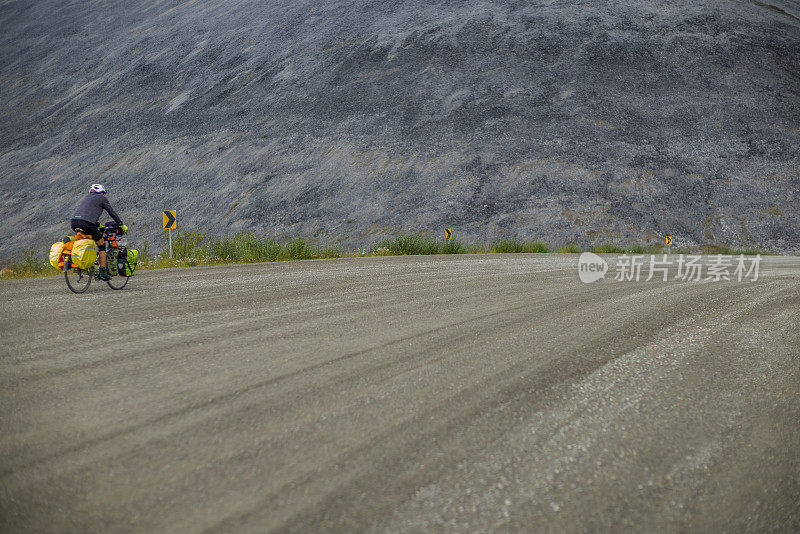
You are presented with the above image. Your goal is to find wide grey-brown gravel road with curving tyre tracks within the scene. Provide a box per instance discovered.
[0,255,800,532]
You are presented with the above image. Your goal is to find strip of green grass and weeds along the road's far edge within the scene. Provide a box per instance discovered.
[0,231,772,280]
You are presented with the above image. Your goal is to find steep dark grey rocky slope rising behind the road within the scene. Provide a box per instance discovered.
[0,0,800,256]
